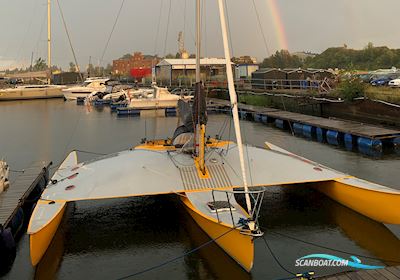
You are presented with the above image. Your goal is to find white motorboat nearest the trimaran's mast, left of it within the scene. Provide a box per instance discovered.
[128,86,192,109]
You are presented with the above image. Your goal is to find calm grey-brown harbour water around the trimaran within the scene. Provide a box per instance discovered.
[0,100,400,279]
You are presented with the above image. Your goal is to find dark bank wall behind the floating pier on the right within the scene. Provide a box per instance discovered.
[208,88,400,128]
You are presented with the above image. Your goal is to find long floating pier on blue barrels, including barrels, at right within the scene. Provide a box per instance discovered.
[207,99,400,156]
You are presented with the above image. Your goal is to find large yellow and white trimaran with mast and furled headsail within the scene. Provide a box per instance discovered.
[28,0,400,272]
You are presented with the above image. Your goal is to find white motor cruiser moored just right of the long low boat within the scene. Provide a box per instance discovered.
[63,78,110,100]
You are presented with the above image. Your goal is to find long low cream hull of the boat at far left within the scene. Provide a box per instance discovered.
[0,85,65,101]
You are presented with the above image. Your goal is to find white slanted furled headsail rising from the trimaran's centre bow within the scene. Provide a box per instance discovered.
[218,0,251,214]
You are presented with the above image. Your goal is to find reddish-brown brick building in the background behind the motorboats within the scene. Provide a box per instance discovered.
[112,52,159,77]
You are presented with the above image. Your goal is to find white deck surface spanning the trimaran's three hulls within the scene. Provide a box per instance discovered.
[29,144,400,233]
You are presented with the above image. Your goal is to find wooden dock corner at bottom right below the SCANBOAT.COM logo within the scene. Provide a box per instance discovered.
[317,266,400,280]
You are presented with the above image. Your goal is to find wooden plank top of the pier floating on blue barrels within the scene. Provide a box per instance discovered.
[208,99,400,140]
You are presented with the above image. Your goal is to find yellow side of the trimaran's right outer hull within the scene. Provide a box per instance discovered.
[312,180,400,224]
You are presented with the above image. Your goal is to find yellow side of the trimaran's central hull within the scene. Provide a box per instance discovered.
[181,197,254,272]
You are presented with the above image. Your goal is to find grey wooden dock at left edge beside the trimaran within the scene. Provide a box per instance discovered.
[0,162,50,228]
